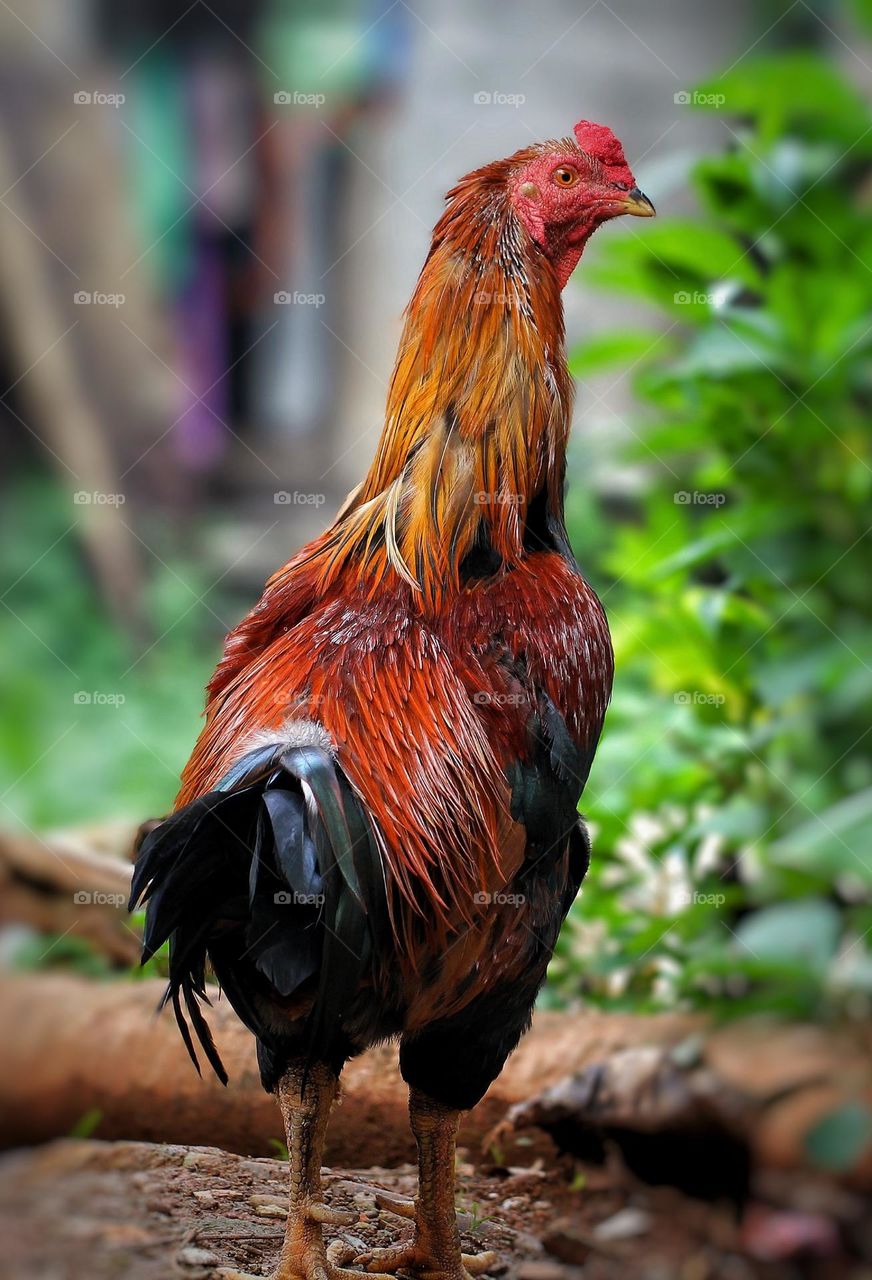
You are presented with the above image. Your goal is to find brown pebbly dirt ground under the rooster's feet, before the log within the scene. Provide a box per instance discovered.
[0,1139,872,1280]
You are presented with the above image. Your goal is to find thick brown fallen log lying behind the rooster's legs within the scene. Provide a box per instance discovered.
[0,974,872,1189]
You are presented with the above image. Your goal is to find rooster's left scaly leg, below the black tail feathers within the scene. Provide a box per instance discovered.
[218,1061,360,1280]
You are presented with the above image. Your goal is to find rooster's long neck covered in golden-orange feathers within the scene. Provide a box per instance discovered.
[302,189,572,609]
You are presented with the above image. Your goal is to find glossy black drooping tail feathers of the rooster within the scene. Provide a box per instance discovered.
[129,733,388,1083]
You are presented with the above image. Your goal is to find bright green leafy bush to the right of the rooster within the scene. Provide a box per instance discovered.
[552,37,872,1015]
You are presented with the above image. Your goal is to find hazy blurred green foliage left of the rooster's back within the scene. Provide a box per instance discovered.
[0,483,217,831]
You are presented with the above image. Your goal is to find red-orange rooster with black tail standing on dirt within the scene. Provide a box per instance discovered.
[132,120,654,1280]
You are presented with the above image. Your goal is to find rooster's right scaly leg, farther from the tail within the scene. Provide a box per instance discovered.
[365,1088,497,1280]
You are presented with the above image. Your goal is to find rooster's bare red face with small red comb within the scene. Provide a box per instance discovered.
[511,120,636,289]
